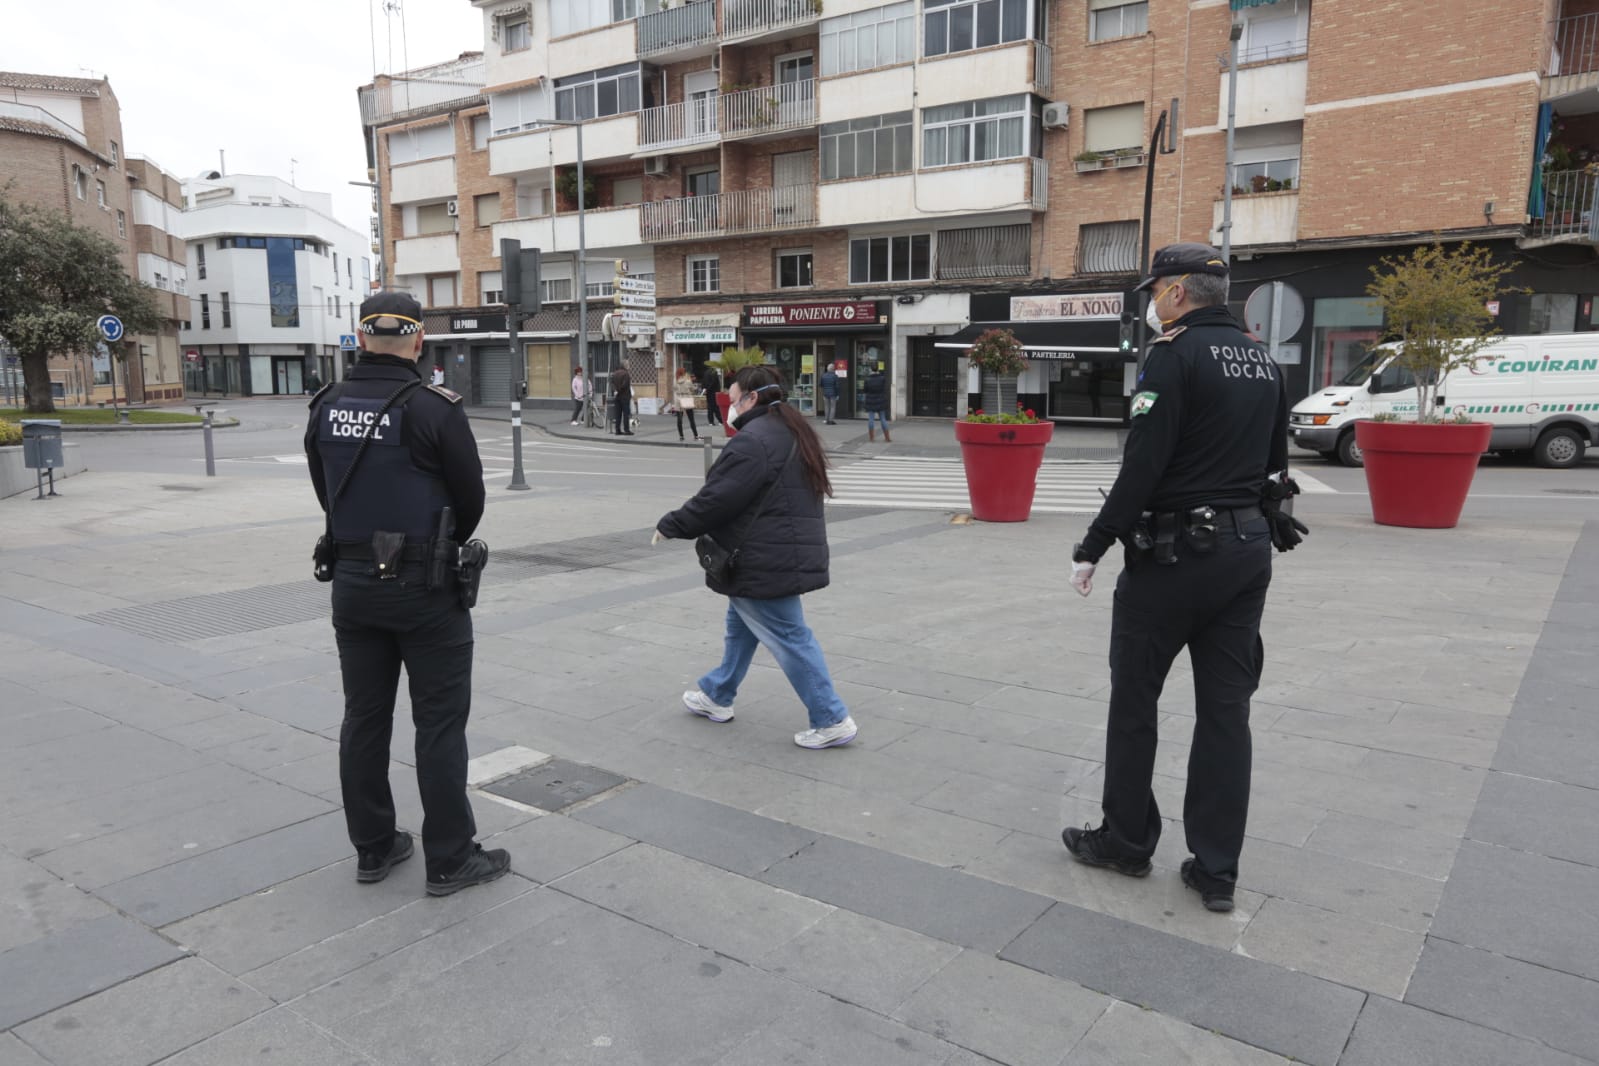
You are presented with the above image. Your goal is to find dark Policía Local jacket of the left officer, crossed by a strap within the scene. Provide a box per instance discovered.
[305,353,484,543]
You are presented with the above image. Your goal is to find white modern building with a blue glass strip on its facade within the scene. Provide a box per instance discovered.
[176,171,373,396]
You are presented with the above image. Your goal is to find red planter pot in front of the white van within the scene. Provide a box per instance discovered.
[1354,420,1493,529]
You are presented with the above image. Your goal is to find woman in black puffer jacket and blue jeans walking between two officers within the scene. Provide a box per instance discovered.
[656,366,855,748]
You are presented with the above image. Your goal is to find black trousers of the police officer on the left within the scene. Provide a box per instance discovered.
[333,559,477,874]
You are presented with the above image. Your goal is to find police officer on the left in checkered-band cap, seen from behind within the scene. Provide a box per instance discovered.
[305,292,510,895]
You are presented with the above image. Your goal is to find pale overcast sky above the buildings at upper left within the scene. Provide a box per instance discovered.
[0,0,483,233]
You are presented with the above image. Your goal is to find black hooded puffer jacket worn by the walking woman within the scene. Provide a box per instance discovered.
[656,406,828,599]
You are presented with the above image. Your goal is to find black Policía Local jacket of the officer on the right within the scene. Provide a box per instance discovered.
[1083,307,1289,563]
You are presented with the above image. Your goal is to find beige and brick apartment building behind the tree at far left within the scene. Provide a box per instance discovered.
[0,72,184,404]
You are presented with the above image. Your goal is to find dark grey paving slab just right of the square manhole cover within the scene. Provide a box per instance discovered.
[572,785,815,876]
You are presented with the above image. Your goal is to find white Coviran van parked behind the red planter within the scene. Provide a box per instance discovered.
[1289,332,1599,467]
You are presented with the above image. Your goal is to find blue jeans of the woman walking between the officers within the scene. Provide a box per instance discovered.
[699,596,849,729]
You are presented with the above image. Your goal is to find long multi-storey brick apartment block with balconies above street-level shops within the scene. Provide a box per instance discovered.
[367,0,1599,424]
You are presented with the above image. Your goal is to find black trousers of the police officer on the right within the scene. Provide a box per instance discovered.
[1103,515,1271,884]
